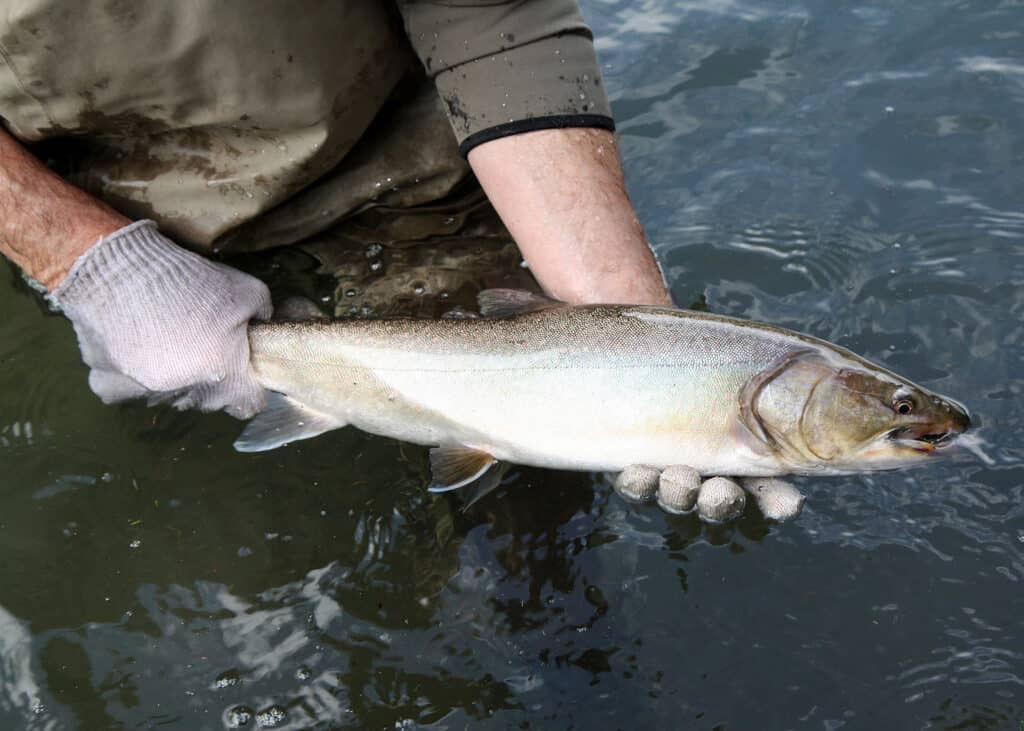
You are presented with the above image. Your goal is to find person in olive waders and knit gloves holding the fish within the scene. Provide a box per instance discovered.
[0,0,798,520]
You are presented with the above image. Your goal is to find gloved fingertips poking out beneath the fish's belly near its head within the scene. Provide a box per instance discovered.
[613,465,804,523]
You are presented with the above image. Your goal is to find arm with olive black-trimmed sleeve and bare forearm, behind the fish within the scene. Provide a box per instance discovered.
[398,0,671,305]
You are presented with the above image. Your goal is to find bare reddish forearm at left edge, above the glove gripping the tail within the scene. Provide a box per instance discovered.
[0,129,129,291]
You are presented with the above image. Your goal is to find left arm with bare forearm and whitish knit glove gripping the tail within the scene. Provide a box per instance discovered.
[0,130,270,418]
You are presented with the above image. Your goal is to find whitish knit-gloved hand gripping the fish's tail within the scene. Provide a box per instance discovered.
[50,221,272,419]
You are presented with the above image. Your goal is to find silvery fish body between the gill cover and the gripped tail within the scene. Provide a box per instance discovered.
[241,306,808,476]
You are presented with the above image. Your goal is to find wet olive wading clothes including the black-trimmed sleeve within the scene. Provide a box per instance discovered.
[0,0,611,310]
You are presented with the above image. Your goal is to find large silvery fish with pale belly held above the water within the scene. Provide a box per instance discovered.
[234,290,971,490]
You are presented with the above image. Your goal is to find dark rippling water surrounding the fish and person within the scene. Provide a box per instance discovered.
[0,0,1024,731]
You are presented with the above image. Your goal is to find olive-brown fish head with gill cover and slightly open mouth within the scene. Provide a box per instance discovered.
[741,351,971,474]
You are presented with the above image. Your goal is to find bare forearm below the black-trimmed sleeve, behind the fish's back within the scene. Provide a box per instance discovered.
[469,128,672,305]
